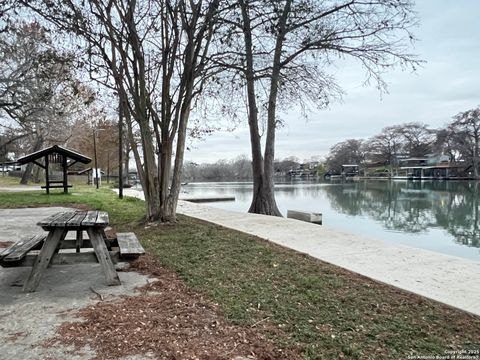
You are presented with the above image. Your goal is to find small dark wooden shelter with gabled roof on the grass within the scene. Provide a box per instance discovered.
[17,145,92,194]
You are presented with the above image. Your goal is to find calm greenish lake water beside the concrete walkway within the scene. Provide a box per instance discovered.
[183,180,480,261]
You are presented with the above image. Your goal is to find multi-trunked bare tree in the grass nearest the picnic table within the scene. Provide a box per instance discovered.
[23,0,220,221]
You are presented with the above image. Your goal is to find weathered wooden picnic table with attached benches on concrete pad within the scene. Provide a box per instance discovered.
[0,210,145,292]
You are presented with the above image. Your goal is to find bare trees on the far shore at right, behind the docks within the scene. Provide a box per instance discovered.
[326,107,480,178]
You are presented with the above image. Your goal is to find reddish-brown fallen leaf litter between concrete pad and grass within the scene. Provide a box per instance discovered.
[42,255,300,360]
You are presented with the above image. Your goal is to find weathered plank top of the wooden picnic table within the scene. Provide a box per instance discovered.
[37,210,109,229]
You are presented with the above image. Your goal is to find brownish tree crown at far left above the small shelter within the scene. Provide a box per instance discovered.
[0,23,93,184]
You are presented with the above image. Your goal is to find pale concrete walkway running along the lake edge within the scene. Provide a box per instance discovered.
[125,190,480,316]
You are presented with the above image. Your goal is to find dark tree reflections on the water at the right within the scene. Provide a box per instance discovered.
[323,181,480,247]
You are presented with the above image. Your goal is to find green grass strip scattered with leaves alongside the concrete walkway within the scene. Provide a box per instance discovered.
[0,188,480,359]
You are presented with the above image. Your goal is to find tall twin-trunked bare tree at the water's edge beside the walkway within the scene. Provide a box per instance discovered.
[218,0,417,215]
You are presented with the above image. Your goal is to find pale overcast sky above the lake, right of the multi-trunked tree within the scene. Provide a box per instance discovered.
[186,0,480,163]
